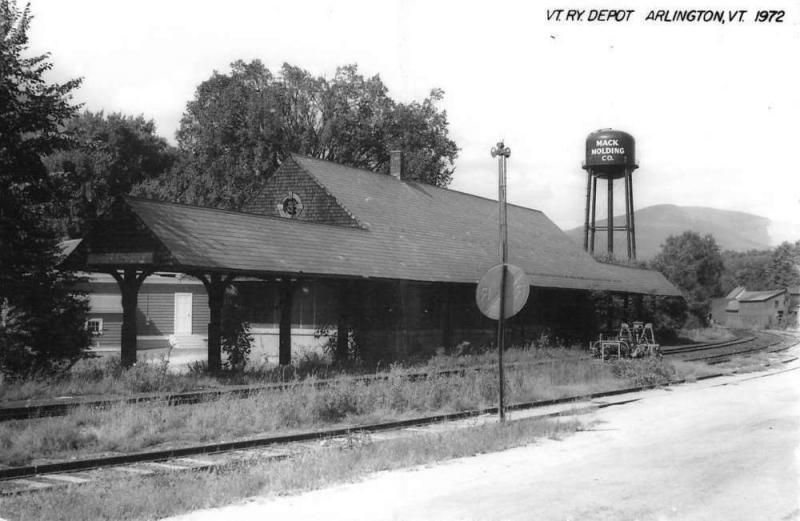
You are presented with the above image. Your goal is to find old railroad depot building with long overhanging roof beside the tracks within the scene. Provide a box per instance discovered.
[65,154,680,369]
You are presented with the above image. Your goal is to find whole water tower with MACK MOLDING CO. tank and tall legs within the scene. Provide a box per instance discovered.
[583,128,639,260]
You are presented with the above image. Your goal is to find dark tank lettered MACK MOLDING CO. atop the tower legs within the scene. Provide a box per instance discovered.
[584,128,636,179]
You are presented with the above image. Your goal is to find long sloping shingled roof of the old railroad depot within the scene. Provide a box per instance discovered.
[71,156,680,296]
